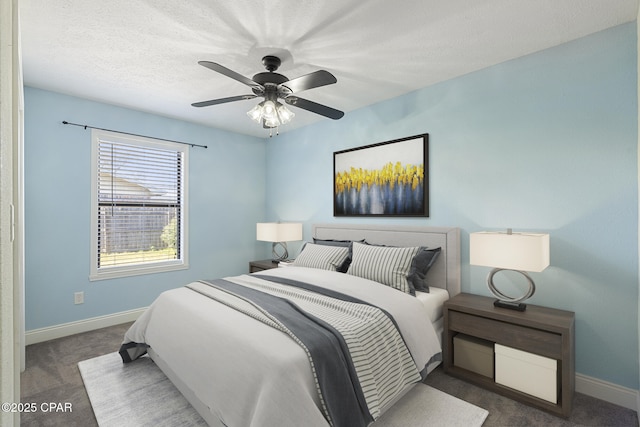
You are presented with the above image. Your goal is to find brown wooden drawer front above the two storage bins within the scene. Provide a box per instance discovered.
[448,310,562,359]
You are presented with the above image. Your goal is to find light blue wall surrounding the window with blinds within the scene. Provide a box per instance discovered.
[25,87,266,331]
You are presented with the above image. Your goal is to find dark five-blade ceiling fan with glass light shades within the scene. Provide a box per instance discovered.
[191,55,344,129]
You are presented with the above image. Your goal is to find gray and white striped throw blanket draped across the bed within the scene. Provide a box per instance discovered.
[187,275,421,427]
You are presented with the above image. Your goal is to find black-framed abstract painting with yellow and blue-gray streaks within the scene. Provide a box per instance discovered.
[333,133,429,217]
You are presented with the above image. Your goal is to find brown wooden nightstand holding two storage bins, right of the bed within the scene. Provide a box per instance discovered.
[442,294,575,417]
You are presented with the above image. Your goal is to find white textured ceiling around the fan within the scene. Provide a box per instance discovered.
[20,0,638,137]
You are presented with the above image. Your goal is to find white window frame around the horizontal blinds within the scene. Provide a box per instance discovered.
[89,129,189,281]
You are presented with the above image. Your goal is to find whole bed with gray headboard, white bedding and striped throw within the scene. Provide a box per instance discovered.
[120,224,460,427]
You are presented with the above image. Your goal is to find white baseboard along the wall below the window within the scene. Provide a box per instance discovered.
[25,307,147,345]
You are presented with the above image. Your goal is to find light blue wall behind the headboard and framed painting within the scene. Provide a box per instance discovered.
[267,23,638,389]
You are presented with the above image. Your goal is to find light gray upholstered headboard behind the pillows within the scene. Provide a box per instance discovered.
[313,224,460,296]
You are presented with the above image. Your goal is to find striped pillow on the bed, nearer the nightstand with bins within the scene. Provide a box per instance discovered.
[347,242,420,294]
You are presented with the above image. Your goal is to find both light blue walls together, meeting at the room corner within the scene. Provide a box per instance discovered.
[25,23,639,389]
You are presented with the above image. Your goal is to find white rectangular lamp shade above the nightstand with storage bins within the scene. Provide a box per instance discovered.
[469,231,549,272]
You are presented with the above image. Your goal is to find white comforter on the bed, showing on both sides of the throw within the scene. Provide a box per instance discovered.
[124,267,441,427]
